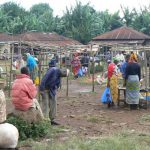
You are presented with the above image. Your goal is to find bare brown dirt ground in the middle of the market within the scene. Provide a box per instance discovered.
[7,79,150,138]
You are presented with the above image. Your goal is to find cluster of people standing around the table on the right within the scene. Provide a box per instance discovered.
[107,52,141,109]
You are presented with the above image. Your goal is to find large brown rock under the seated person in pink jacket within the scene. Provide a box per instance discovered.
[9,108,43,123]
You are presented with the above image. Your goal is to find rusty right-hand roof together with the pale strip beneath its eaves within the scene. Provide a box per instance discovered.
[90,26,150,45]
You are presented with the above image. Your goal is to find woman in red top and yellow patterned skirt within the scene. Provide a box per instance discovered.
[107,58,118,106]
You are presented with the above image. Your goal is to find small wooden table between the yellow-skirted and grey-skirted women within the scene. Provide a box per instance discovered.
[118,87,126,106]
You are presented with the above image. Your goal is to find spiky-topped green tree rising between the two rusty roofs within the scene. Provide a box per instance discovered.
[61,2,99,44]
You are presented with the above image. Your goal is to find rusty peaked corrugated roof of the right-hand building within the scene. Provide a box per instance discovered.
[92,26,150,41]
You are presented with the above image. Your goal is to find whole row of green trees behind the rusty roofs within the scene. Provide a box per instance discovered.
[0,1,150,44]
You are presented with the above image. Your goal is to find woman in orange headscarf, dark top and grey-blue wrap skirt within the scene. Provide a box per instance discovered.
[125,55,141,109]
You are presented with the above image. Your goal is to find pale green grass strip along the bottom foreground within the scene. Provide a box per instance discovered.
[19,133,150,150]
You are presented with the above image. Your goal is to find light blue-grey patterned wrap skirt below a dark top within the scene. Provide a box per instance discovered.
[126,75,140,104]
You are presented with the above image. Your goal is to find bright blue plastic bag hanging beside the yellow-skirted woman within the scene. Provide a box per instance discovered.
[101,87,112,104]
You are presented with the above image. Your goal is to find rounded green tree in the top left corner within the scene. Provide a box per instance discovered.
[0,2,26,34]
